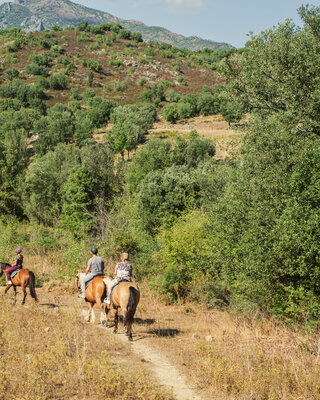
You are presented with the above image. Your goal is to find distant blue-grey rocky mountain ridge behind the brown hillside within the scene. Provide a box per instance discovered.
[0,0,232,50]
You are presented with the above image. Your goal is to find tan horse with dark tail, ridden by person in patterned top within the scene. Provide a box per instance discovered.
[105,278,140,340]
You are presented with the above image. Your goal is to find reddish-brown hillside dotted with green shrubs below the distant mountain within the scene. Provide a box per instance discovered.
[0,24,222,105]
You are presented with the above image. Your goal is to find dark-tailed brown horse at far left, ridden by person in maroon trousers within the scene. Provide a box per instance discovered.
[0,263,38,304]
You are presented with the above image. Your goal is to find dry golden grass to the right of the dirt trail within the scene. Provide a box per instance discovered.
[131,286,320,400]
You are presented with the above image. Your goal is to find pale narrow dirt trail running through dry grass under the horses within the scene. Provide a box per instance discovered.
[23,289,209,400]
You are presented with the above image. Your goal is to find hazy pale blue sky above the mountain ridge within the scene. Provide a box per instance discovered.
[71,0,306,47]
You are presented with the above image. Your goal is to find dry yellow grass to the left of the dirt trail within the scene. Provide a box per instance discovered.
[0,291,173,400]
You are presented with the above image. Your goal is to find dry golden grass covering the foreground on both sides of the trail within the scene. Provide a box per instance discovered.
[0,255,320,400]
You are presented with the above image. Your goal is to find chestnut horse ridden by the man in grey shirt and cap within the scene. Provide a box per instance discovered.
[76,272,107,325]
